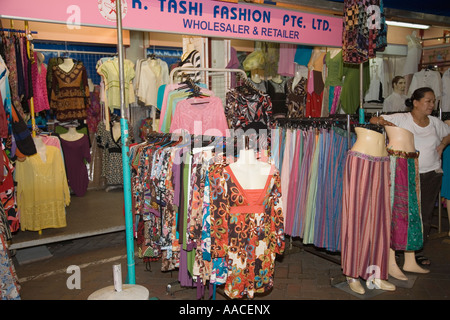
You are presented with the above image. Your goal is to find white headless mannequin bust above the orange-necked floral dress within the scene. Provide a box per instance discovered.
[229,149,272,189]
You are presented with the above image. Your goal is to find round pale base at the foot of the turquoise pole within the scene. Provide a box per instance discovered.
[88,284,150,300]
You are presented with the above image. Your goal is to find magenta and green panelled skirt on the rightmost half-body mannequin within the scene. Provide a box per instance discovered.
[388,149,423,251]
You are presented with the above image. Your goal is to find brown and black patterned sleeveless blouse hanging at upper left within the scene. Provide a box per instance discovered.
[50,61,90,121]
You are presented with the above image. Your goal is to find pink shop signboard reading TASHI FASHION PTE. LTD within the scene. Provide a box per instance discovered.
[0,0,343,47]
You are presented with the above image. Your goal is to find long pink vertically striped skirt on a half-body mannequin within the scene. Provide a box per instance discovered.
[341,151,391,280]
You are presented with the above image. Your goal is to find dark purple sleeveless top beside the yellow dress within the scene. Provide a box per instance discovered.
[60,135,91,197]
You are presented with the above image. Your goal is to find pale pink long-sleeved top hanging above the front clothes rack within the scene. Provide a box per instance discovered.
[170,96,229,137]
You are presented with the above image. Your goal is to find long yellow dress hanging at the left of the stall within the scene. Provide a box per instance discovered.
[16,145,70,231]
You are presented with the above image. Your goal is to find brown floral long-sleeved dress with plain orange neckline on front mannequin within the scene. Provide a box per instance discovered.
[210,166,284,298]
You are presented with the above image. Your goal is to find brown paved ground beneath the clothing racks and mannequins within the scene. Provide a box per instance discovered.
[13,225,450,301]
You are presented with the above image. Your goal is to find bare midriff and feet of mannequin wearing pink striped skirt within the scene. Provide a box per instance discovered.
[347,128,395,294]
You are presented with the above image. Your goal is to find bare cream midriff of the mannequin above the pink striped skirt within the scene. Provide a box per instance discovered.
[352,128,388,157]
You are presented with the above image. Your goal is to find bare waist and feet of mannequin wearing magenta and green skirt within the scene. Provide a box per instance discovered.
[385,126,430,280]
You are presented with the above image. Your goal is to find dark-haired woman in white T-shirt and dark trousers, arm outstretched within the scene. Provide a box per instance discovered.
[370,87,450,265]
